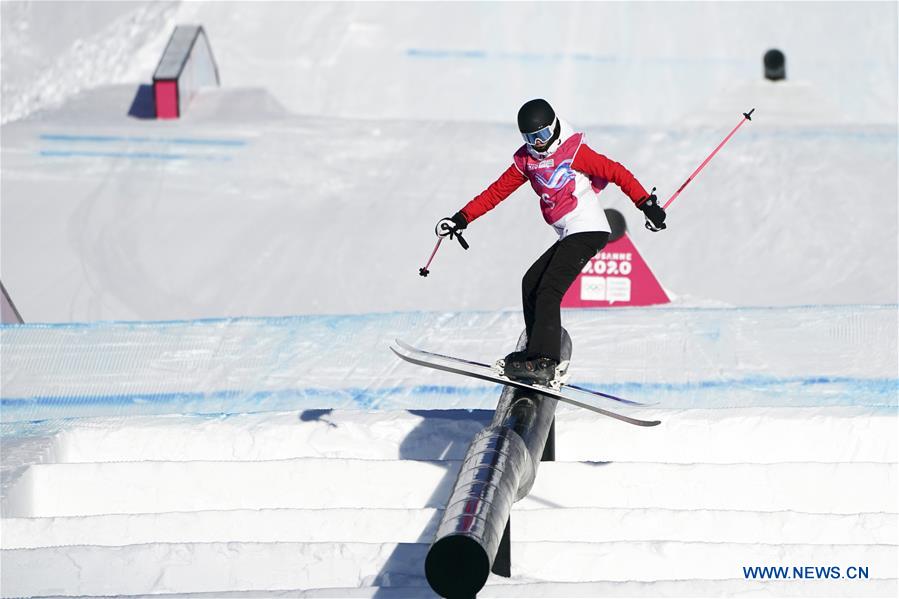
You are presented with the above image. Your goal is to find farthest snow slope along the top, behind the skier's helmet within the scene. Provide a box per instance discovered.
[2,1,899,126]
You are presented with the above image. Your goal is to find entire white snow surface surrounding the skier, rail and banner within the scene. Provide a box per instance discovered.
[0,1,899,597]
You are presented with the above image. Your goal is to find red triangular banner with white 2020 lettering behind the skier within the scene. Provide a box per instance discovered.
[562,233,671,308]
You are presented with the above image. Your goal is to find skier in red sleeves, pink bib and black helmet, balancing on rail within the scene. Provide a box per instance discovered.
[436,99,666,384]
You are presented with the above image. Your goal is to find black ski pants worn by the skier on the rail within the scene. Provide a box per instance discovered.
[521,231,609,361]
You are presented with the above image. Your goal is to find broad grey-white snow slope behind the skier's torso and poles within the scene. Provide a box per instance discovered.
[0,88,897,322]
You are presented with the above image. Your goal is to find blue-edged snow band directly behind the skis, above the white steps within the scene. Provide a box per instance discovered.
[0,306,899,422]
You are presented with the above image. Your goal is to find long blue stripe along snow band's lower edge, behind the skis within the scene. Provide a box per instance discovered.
[0,377,899,435]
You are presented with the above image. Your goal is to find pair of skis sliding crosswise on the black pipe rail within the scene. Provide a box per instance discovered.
[390,339,660,426]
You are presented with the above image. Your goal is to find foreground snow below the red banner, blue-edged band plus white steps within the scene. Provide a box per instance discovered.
[0,306,899,597]
